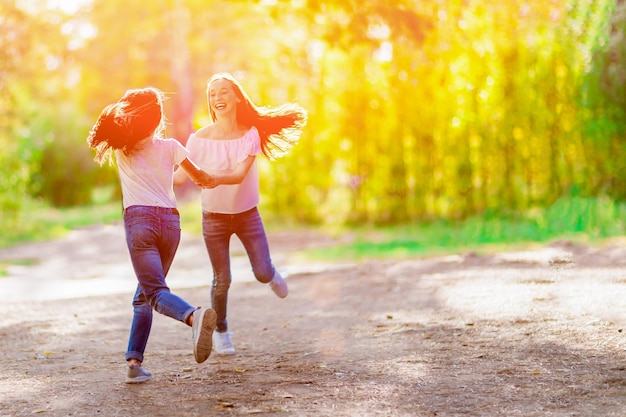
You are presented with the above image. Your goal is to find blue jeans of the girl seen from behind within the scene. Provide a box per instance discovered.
[124,206,195,362]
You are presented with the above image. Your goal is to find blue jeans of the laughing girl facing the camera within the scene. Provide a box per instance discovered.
[202,207,275,332]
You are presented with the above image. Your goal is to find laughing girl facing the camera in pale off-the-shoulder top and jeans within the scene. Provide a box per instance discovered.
[175,73,307,355]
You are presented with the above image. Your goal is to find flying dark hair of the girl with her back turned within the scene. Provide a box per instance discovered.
[87,87,165,165]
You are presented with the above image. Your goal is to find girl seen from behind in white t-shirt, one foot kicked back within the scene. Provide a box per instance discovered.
[87,87,216,383]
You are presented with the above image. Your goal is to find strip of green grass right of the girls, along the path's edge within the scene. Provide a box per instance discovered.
[303,196,626,261]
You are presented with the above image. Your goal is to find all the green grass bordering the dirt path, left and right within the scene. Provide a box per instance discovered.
[0,190,626,262]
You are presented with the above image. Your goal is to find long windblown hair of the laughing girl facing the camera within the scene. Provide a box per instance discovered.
[206,72,307,159]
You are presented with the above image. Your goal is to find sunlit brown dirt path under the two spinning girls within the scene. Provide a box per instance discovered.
[0,227,626,417]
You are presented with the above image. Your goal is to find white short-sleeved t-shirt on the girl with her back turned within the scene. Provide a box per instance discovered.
[115,139,189,208]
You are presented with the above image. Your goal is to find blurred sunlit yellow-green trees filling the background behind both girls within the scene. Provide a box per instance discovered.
[0,0,626,255]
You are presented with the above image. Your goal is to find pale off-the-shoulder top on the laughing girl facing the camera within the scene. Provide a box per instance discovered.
[187,126,261,214]
